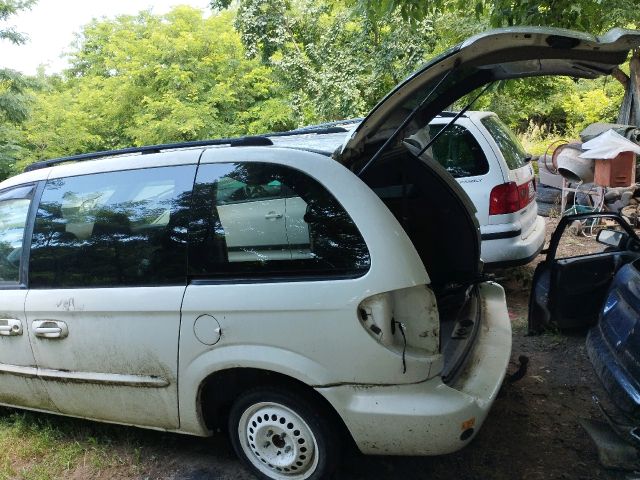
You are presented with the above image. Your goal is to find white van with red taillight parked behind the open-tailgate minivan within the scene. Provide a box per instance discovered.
[271,111,545,267]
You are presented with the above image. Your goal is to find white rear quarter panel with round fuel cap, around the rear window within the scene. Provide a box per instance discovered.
[179,147,450,435]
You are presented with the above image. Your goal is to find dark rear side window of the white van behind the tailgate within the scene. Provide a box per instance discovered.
[429,124,489,178]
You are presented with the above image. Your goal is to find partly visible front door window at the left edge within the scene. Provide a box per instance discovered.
[0,185,35,286]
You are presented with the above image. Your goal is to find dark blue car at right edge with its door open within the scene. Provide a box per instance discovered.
[529,214,640,420]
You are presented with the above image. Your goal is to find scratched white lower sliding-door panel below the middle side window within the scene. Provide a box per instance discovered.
[25,286,185,429]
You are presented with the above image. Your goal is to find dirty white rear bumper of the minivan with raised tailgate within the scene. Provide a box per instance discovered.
[317,283,511,455]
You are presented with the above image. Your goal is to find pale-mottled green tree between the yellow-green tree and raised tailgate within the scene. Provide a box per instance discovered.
[212,0,450,124]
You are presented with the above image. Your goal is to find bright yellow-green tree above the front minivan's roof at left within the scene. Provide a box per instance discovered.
[18,7,295,169]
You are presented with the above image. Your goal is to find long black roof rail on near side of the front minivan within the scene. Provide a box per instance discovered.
[24,136,273,172]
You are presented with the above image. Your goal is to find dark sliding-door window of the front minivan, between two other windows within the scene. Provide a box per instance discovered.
[29,165,196,288]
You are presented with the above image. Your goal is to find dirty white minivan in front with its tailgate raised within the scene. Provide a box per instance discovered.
[0,28,640,480]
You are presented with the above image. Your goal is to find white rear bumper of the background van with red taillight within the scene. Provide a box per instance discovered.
[481,215,546,267]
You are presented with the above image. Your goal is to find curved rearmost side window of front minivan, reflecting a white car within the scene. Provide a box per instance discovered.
[189,162,370,280]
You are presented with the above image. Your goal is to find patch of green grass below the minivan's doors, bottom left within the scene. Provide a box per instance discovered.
[0,408,145,480]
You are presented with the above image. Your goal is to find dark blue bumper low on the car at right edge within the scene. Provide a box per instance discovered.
[587,325,640,419]
